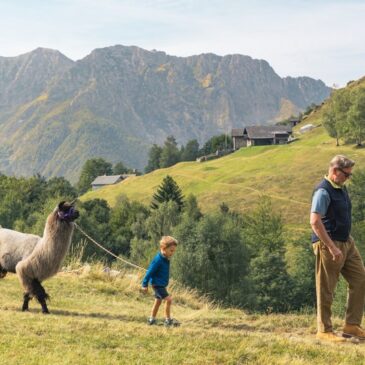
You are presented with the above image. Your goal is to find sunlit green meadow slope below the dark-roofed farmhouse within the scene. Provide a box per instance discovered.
[82,111,365,225]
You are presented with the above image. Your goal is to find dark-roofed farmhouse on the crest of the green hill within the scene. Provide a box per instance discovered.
[232,125,292,150]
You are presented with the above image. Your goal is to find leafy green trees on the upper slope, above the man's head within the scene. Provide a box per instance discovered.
[322,87,365,146]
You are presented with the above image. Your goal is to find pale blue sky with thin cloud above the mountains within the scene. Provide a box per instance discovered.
[0,0,365,86]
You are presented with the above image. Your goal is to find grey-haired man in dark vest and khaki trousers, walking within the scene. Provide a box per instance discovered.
[310,155,365,342]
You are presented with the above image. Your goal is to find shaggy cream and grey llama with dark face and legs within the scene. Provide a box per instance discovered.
[0,202,79,313]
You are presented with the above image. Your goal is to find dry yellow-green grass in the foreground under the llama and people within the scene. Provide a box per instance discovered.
[0,266,365,365]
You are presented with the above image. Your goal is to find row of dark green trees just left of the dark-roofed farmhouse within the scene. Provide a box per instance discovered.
[145,134,233,173]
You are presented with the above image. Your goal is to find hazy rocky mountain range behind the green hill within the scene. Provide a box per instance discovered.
[0,46,330,182]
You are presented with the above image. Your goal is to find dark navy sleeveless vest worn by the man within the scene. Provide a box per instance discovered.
[312,179,352,243]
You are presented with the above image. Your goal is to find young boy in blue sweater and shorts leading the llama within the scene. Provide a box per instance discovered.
[142,236,180,327]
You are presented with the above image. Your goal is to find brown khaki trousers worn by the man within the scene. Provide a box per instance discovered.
[313,237,365,332]
